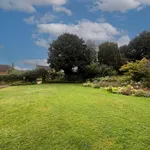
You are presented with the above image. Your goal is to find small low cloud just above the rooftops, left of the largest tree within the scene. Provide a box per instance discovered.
[22,59,48,67]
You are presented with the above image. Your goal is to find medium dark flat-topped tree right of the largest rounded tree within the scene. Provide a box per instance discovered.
[98,42,122,70]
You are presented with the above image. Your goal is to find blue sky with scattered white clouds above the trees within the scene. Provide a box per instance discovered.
[0,0,150,69]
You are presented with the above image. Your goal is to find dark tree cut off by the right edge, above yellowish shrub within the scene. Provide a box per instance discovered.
[126,31,150,61]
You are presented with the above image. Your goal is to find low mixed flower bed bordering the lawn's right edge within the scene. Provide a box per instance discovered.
[83,76,150,97]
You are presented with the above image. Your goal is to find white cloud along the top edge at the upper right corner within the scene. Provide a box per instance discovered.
[95,0,150,12]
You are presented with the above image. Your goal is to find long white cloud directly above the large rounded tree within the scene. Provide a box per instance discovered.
[38,20,120,42]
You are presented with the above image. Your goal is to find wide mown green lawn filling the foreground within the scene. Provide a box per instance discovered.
[0,84,150,150]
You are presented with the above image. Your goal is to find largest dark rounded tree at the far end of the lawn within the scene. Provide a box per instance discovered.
[48,33,92,78]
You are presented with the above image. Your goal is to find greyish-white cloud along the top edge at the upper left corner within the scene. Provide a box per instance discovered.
[0,0,67,13]
